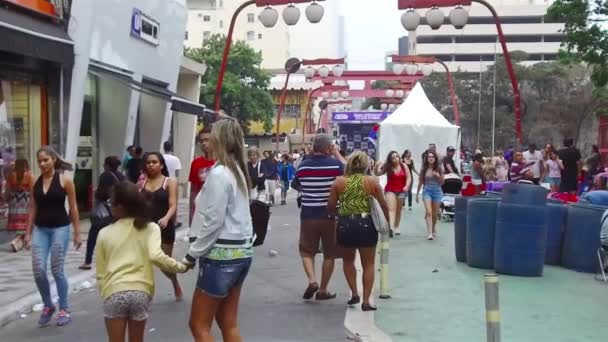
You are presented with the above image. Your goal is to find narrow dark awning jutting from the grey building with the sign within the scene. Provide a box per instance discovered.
[89,65,209,116]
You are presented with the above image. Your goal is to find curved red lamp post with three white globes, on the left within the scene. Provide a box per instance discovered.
[215,0,324,112]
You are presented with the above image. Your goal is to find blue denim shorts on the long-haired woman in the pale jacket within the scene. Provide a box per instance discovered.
[196,257,251,298]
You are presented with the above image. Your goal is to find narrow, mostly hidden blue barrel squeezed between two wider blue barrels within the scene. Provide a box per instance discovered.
[545,201,568,265]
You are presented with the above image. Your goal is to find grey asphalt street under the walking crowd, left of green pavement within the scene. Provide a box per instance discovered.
[0,195,349,342]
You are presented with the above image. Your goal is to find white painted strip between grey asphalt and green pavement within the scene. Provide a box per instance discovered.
[344,253,392,342]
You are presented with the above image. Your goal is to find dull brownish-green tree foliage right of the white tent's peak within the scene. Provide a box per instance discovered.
[422,57,608,151]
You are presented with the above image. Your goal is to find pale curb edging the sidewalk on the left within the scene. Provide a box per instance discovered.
[0,227,189,328]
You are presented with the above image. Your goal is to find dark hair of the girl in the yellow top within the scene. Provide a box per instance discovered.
[111,181,152,229]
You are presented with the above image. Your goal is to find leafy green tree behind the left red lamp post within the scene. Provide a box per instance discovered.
[185,34,274,133]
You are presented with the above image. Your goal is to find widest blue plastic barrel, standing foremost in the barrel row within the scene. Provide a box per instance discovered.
[494,202,547,277]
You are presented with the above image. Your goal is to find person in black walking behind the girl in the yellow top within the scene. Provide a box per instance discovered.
[78,156,125,270]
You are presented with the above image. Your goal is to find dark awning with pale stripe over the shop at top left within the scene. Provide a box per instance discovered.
[0,7,74,65]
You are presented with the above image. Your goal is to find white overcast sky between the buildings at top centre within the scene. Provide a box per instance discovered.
[341,0,406,70]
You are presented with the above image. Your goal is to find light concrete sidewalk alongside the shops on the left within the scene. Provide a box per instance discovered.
[0,199,188,327]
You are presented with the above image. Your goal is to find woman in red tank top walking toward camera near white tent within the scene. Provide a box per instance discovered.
[374,151,412,236]
